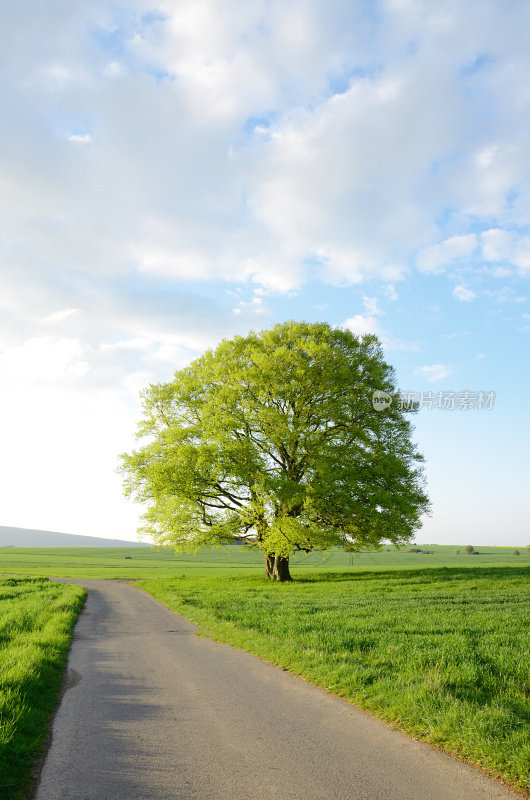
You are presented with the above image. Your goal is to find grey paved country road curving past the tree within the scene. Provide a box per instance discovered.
[36,580,517,800]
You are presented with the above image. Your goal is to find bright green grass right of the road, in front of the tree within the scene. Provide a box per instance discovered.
[139,566,530,792]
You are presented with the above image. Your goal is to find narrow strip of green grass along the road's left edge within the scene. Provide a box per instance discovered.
[0,578,86,800]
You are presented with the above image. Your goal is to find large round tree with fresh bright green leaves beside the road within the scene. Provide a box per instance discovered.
[121,321,428,581]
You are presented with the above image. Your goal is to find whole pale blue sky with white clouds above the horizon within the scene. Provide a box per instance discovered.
[0,0,530,546]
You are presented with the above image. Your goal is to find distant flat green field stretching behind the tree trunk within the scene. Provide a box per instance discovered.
[0,543,530,578]
